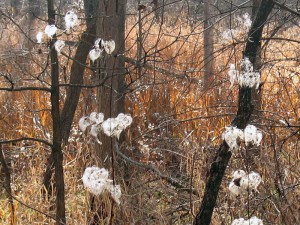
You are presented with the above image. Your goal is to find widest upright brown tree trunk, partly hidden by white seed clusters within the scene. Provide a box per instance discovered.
[90,0,126,225]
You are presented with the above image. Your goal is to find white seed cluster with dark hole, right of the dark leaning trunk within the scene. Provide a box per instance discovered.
[228,170,262,197]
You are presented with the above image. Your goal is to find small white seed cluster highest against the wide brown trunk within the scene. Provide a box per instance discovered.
[89,38,116,63]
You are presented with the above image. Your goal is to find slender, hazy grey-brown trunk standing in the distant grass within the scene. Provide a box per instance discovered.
[203,0,214,90]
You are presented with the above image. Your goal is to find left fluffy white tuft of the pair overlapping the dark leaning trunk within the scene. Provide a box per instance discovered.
[222,126,244,150]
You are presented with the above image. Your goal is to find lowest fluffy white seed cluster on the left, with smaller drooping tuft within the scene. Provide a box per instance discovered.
[82,166,122,204]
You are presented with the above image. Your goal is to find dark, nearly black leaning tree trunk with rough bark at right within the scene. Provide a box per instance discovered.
[194,0,273,225]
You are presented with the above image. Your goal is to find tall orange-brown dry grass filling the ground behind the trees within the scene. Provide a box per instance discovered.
[0,7,300,225]
